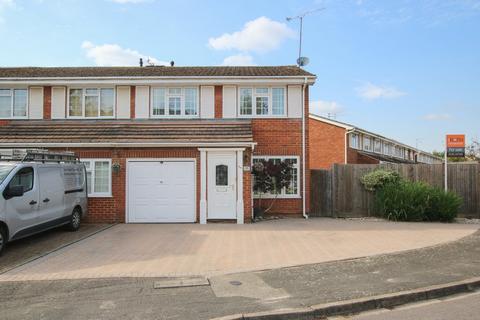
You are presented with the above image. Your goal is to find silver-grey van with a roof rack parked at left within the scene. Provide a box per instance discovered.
[0,151,87,253]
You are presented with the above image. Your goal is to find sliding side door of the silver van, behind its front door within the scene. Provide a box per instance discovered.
[37,165,65,227]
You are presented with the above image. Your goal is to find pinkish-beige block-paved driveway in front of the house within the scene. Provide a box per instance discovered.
[0,218,479,281]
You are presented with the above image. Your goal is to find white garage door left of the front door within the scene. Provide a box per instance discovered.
[127,161,195,223]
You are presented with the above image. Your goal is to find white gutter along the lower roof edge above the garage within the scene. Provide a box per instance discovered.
[0,142,257,149]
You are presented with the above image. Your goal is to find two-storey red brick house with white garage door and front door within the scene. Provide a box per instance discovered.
[0,66,316,223]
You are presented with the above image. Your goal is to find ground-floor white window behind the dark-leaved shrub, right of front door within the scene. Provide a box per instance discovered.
[252,156,300,199]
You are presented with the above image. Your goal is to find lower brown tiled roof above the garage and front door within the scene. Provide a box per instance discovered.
[0,120,253,146]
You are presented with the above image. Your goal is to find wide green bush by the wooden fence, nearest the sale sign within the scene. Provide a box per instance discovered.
[375,180,462,222]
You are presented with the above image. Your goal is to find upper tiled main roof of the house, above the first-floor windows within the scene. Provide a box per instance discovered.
[0,66,314,78]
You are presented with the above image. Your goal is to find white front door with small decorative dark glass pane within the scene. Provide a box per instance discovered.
[207,152,237,219]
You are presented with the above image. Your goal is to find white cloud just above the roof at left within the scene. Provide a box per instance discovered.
[82,41,169,66]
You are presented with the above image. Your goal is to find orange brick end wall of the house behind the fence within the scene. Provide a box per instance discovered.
[308,118,346,169]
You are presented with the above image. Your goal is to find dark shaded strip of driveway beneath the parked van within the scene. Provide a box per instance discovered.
[0,224,111,274]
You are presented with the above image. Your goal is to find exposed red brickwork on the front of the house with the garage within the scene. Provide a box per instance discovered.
[0,85,315,223]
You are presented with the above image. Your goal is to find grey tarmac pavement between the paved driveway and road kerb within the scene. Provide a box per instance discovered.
[0,221,480,320]
